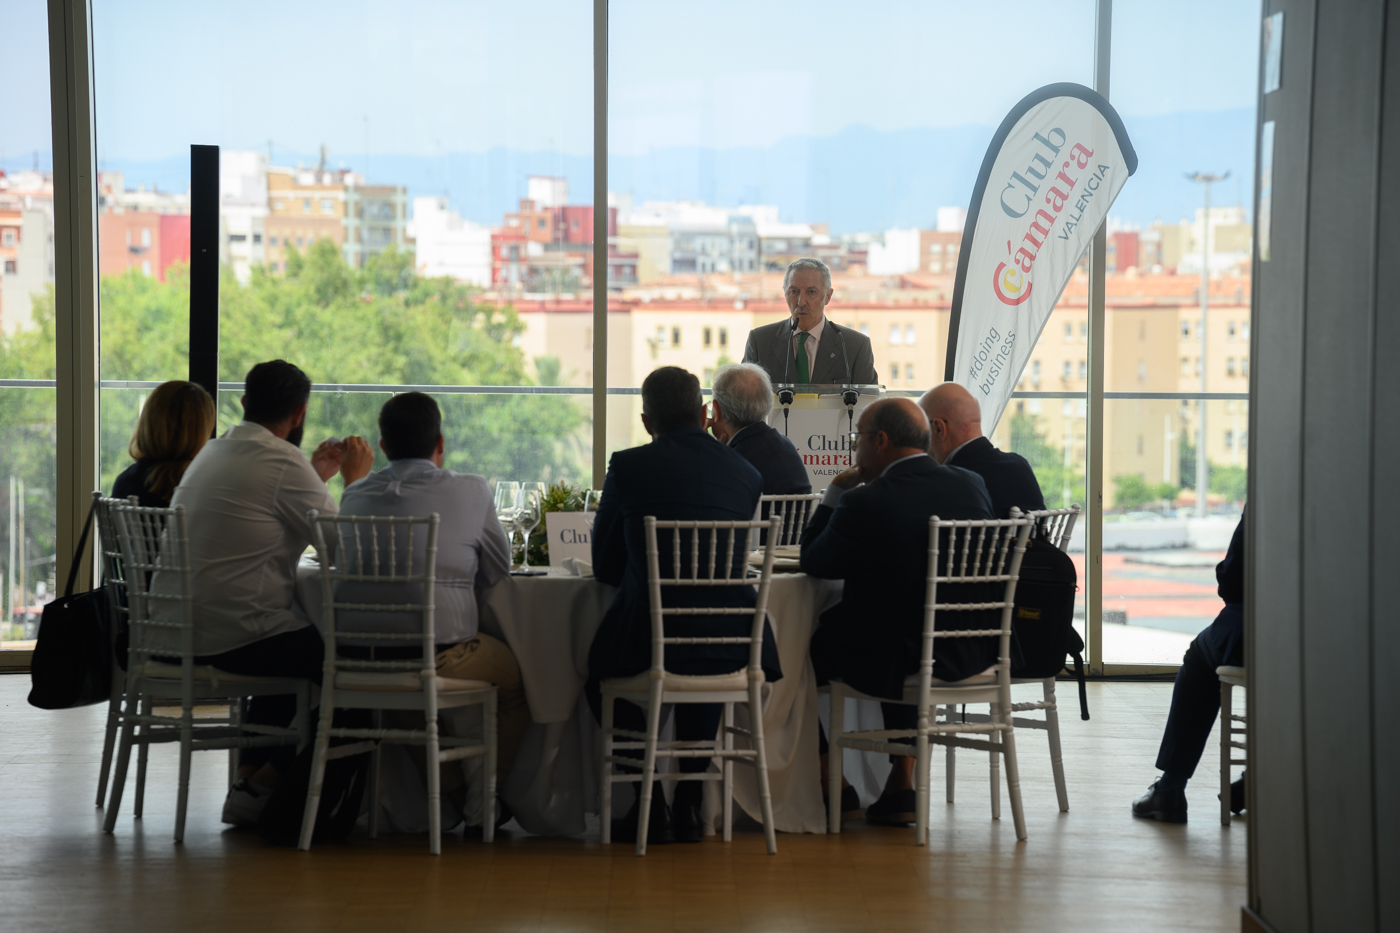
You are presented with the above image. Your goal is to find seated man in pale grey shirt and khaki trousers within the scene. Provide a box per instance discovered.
[337,392,529,817]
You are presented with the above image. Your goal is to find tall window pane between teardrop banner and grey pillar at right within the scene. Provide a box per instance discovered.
[1103,0,1260,664]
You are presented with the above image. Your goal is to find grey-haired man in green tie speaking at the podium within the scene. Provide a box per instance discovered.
[743,258,875,385]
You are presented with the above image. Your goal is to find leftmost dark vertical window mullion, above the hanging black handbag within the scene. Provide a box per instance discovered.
[49,0,98,588]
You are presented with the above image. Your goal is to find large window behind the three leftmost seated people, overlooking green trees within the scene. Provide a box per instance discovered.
[94,0,588,501]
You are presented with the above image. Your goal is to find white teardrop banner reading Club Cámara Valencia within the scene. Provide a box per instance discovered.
[944,84,1137,434]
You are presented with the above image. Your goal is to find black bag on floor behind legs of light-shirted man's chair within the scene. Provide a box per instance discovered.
[258,740,370,846]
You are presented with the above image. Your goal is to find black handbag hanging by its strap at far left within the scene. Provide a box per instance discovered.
[29,503,112,709]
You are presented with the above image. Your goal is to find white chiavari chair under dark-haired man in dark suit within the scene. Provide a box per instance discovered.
[599,516,781,856]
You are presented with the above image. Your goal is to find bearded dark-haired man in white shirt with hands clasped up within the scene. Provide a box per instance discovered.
[153,360,374,824]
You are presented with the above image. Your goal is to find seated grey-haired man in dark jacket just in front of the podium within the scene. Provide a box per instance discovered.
[710,363,812,496]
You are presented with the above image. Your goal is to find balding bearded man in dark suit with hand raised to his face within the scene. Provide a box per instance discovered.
[802,398,997,825]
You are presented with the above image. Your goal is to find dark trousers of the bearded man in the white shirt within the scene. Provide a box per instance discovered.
[195,625,326,775]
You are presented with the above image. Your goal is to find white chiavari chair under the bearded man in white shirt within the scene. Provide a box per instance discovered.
[102,500,311,842]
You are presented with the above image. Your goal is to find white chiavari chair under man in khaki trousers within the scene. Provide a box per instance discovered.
[298,510,496,855]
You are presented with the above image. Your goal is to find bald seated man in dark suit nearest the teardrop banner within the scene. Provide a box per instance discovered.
[918,382,1046,518]
